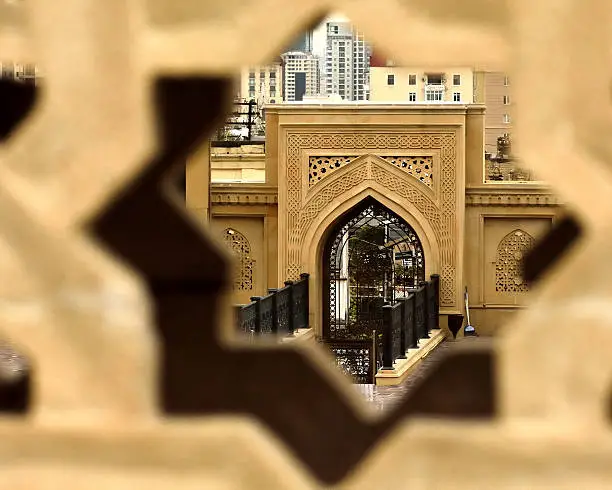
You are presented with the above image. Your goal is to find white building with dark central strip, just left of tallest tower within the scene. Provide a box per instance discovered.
[282,51,320,102]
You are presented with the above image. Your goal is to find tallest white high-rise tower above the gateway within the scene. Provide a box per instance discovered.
[323,22,370,100]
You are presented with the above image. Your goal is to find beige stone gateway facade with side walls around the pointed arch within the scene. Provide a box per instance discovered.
[212,103,560,334]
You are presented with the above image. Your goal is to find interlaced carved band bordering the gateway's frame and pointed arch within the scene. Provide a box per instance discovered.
[285,131,457,307]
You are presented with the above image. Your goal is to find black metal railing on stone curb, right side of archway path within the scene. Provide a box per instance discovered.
[382,274,440,369]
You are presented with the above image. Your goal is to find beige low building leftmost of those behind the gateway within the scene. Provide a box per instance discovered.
[239,60,283,104]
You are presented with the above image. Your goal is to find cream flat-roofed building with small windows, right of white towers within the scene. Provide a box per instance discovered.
[370,66,474,104]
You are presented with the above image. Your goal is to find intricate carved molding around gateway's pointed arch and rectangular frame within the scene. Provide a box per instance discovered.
[279,129,461,308]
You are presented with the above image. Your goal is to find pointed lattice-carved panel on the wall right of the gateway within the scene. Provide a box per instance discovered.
[495,229,535,294]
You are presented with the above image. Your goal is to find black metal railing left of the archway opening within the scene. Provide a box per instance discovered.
[235,274,309,336]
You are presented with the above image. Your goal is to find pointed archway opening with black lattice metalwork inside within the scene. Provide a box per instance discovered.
[322,197,425,382]
